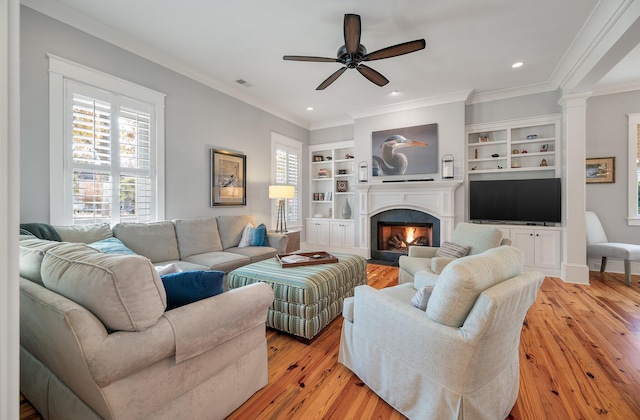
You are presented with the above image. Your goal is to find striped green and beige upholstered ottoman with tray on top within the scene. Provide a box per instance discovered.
[227,253,367,340]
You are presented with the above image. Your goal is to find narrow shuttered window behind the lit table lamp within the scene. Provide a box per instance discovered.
[271,133,302,227]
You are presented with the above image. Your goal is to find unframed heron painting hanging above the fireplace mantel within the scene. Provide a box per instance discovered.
[371,123,438,178]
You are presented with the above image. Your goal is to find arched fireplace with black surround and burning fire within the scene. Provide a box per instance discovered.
[370,209,440,262]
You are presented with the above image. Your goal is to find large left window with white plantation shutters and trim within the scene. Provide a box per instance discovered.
[49,56,164,225]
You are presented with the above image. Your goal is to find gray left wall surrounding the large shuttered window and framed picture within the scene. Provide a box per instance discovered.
[20,7,309,226]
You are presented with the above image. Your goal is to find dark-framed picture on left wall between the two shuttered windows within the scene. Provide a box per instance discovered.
[210,149,247,207]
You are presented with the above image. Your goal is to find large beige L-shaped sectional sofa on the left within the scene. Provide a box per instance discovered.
[20,216,286,419]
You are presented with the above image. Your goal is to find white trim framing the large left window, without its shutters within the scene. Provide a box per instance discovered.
[47,54,166,225]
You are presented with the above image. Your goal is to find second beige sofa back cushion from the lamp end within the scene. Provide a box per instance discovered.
[173,217,222,259]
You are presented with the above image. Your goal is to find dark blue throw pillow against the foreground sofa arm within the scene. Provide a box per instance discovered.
[160,270,224,311]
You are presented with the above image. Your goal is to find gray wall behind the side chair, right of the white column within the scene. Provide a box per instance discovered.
[586,91,640,244]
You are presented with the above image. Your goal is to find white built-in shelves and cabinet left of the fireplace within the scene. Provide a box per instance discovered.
[306,140,358,250]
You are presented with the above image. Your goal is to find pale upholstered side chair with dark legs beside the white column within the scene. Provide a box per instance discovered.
[586,211,640,286]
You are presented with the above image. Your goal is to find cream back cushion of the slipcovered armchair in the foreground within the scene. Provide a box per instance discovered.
[427,245,524,327]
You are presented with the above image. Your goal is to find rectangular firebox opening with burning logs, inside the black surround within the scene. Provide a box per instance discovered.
[378,222,433,254]
